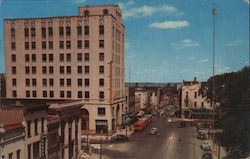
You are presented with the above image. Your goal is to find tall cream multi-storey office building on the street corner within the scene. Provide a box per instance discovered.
[4,5,125,134]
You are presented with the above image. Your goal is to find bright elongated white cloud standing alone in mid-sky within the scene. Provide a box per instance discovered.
[149,21,190,29]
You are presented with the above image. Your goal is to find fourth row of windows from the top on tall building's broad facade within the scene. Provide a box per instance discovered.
[12,66,104,75]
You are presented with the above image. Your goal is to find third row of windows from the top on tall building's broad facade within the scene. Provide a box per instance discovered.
[11,53,104,62]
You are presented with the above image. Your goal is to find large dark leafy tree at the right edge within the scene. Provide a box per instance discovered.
[199,67,250,158]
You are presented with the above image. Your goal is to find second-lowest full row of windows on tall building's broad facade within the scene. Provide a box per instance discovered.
[12,78,105,87]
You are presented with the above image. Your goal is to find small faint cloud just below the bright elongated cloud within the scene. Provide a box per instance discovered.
[171,39,200,48]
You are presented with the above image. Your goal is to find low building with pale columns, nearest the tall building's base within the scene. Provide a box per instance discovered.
[48,101,83,159]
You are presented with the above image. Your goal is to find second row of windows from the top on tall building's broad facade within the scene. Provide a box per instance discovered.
[11,40,104,50]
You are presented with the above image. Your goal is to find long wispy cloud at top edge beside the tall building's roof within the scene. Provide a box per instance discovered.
[118,0,183,18]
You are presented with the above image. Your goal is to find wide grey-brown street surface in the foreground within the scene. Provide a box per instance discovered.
[94,116,202,159]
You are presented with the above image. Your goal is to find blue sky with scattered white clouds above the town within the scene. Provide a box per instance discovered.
[0,0,249,82]
